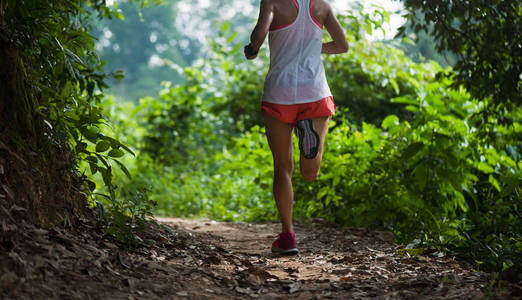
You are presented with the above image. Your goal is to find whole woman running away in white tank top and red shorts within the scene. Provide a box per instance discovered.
[245,0,348,254]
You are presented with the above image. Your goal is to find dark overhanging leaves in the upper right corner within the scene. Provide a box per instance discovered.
[399,0,522,110]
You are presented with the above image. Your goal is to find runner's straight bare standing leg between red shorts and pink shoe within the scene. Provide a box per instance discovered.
[263,112,294,232]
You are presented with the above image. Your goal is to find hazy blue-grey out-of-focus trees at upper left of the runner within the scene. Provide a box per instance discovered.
[91,0,258,102]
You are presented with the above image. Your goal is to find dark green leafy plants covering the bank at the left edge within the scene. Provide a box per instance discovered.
[0,0,160,244]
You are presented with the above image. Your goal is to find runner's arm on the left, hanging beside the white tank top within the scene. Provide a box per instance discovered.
[245,0,274,59]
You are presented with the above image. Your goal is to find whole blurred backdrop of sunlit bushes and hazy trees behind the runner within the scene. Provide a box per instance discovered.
[87,1,522,274]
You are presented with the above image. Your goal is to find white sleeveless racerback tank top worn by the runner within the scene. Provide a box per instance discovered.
[262,0,332,104]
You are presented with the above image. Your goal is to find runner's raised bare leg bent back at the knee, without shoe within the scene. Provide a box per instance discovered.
[299,117,330,182]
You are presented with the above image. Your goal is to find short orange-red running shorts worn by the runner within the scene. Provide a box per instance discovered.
[261,96,335,126]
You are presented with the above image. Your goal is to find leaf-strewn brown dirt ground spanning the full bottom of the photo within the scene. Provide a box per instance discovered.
[0,218,522,300]
